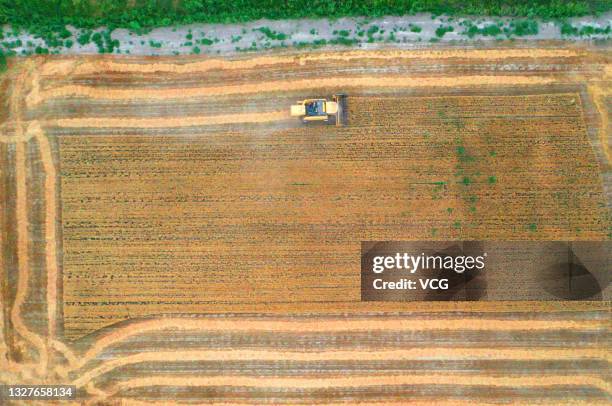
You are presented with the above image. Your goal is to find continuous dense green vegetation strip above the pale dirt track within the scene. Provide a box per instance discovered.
[0,0,612,32]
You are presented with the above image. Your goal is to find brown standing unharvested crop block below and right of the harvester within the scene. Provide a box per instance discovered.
[59,93,606,337]
